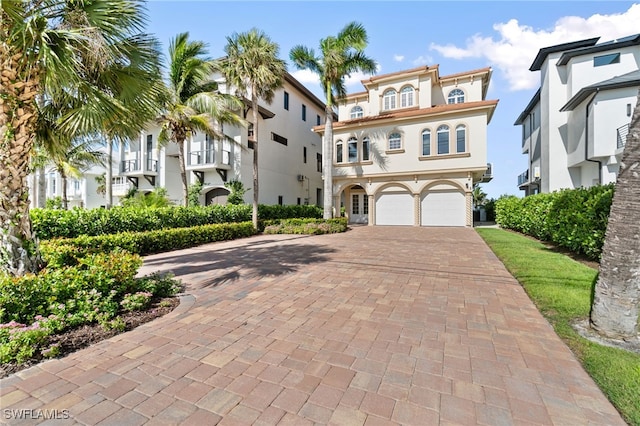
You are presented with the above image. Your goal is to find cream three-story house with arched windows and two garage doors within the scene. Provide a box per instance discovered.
[314,65,498,226]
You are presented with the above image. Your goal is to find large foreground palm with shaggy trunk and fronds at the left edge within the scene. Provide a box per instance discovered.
[0,0,156,275]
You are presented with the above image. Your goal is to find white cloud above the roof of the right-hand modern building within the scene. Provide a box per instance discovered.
[429,4,640,91]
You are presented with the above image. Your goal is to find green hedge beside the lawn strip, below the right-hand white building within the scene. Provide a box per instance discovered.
[496,184,614,259]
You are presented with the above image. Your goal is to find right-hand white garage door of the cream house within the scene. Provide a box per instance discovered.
[420,191,467,226]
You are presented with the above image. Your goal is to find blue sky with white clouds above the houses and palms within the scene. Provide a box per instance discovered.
[147,0,640,198]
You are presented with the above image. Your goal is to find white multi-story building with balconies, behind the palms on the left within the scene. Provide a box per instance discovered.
[114,74,324,205]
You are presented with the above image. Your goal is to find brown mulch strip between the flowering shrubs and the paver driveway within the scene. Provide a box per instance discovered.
[0,297,180,379]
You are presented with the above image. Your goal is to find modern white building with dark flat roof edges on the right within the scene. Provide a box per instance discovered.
[515,34,640,195]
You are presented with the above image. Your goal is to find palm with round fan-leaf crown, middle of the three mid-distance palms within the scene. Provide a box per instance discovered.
[222,28,286,228]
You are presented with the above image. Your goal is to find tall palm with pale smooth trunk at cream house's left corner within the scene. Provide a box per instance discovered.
[289,22,376,219]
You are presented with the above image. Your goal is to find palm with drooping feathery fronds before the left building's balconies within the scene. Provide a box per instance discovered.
[157,33,243,207]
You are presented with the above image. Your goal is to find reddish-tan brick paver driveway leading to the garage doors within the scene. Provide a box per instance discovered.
[0,227,624,426]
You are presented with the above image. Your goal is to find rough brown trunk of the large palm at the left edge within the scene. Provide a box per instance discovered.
[0,42,42,276]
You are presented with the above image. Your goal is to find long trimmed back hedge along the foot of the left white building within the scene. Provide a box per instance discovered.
[31,204,322,240]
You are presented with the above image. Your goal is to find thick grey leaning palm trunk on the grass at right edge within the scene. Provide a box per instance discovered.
[591,90,640,340]
